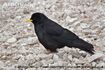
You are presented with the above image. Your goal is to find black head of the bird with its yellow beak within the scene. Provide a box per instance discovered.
[26,12,46,24]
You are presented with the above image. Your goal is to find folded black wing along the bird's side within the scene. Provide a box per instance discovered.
[45,20,78,43]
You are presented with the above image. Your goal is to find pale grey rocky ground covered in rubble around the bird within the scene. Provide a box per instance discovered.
[0,0,105,70]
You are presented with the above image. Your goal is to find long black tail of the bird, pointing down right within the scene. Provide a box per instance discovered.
[67,38,94,54]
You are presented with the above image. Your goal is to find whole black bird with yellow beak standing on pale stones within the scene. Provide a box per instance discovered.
[28,12,94,54]
